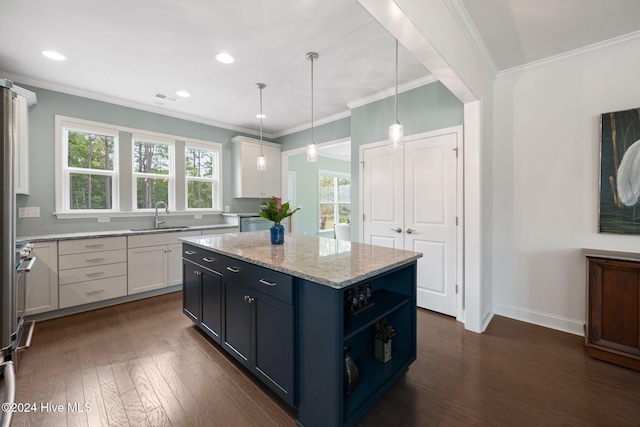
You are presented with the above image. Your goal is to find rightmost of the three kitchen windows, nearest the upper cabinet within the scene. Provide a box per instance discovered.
[184,142,222,209]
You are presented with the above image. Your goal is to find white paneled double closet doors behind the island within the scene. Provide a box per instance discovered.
[361,127,462,317]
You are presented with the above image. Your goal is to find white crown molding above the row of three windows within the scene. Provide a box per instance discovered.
[0,70,275,139]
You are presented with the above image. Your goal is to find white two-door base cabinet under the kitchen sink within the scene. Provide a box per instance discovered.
[127,231,201,295]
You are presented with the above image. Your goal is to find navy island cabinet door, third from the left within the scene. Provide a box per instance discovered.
[223,277,251,367]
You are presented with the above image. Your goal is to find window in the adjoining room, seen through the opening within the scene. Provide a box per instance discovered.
[318,171,351,230]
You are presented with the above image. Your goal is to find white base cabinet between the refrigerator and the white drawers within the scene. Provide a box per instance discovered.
[25,242,58,316]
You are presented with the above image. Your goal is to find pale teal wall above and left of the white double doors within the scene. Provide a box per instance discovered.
[277,82,464,240]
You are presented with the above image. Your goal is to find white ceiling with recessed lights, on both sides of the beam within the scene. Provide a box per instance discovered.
[0,0,640,135]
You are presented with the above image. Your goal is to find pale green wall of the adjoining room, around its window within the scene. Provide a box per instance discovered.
[289,153,353,237]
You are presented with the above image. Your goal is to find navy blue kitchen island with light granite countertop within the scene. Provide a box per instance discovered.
[181,231,422,427]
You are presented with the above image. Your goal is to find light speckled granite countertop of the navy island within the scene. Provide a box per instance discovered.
[180,230,422,289]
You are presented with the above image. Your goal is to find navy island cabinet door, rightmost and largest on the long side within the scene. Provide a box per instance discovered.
[251,290,295,406]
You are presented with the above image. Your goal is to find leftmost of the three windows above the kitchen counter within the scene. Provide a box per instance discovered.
[57,122,118,212]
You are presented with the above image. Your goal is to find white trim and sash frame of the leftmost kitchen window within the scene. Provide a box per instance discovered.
[55,116,120,218]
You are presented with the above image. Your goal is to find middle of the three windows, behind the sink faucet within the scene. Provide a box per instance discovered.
[132,135,175,209]
